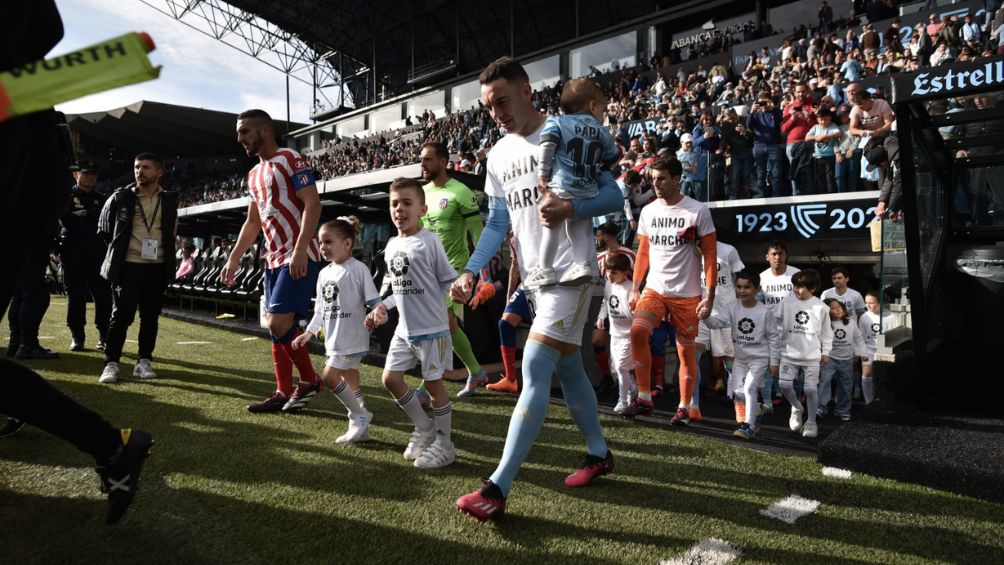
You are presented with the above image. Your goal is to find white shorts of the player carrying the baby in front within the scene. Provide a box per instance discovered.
[526,284,592,346]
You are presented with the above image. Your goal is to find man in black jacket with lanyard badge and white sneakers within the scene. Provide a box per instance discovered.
[97,153,178,383]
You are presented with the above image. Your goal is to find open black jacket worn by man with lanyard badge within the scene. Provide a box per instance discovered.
[97,184,178,282]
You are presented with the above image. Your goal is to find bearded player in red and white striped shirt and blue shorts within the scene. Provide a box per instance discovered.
[220,109,321,412]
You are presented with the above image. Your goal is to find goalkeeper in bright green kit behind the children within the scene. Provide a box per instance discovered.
[421,142,488,398]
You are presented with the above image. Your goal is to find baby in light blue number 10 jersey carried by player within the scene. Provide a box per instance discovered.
[524,78,619,288]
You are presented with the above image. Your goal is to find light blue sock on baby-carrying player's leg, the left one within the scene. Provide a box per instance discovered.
[491,340,559,496]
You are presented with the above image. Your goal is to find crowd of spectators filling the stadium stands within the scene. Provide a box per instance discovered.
[170,0,1004,214]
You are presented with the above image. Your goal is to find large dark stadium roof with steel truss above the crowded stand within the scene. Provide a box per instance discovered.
[141,0,741,113]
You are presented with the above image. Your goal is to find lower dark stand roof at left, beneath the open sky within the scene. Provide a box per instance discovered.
[66,100,306,159]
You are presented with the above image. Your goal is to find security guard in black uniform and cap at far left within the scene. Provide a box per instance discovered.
[59,161,111,351]
